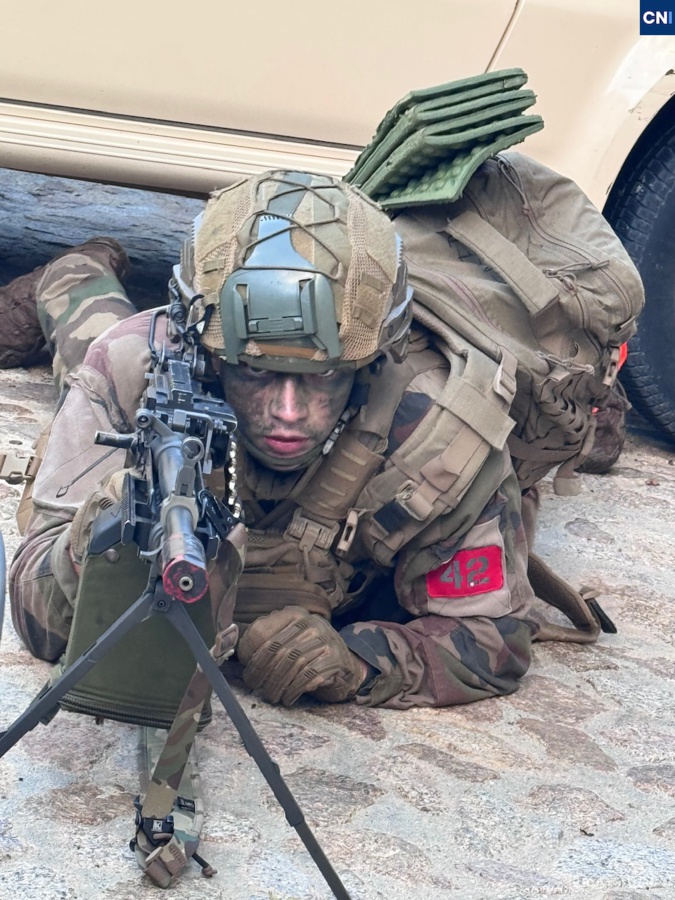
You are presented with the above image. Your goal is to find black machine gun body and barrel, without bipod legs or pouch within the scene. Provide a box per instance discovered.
[89,307,241,603]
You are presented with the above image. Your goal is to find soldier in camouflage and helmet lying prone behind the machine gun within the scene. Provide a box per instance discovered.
[3,171,538,709]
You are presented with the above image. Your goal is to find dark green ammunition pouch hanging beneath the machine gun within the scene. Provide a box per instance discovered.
[58,543,215,729]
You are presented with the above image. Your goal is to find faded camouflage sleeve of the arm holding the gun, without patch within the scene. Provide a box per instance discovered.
[9,313,156,661]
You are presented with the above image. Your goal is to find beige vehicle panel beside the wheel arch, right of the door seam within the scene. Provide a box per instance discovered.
[492,0,675,208]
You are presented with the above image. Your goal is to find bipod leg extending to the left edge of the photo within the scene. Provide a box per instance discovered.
[0,571,157,757]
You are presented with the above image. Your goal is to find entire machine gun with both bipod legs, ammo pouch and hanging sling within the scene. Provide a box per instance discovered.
[0,303,349,900]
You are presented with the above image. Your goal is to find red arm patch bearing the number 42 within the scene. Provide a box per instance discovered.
[427,545,504,597]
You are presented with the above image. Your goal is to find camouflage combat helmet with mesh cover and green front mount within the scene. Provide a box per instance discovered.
[174,170,412,372]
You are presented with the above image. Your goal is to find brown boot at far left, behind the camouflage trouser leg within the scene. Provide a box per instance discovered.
[0,237,129,369]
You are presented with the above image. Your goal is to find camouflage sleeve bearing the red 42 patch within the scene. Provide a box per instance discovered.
[340,453,534,709]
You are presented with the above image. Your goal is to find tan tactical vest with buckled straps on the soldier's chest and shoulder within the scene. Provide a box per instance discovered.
[235,328,515,623]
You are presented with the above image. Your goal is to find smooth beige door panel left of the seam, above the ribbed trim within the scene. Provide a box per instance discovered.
[0,0,516,145]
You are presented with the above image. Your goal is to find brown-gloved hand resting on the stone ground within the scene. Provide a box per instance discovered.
[237,606,367,706]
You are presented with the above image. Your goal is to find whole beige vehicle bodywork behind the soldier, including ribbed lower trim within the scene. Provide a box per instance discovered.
[0,0,675,207]
